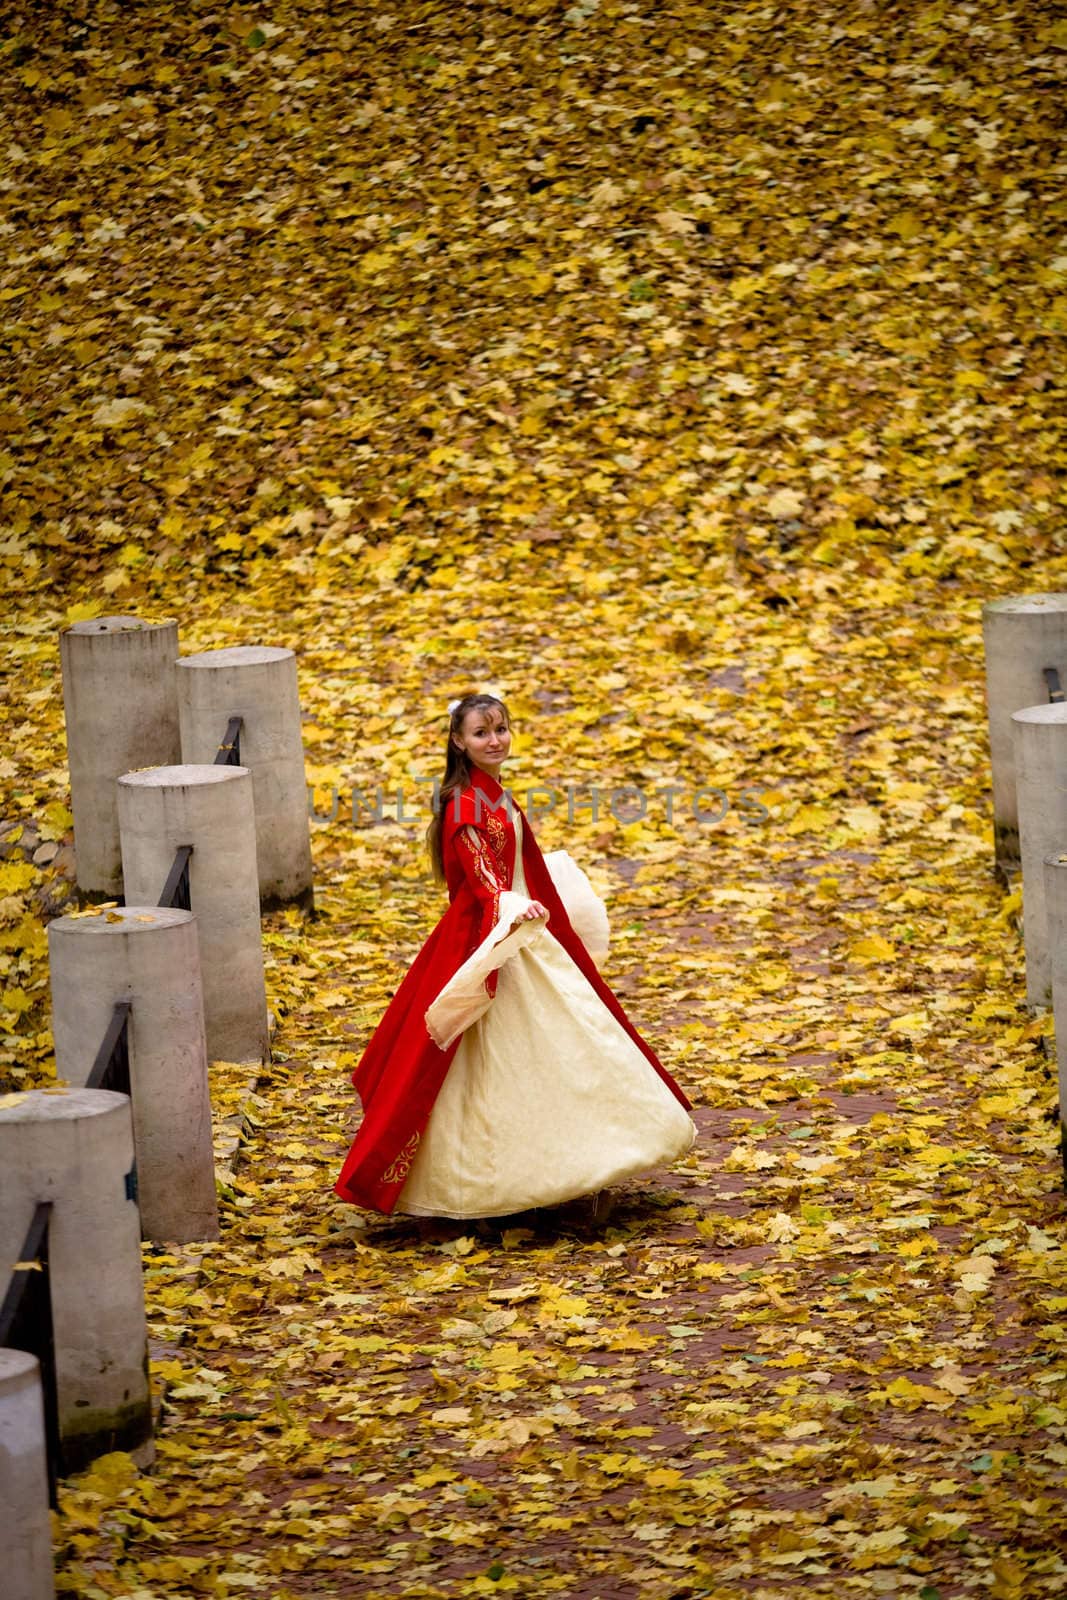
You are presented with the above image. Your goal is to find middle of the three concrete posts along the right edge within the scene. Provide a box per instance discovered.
[1011,704,1067,1006]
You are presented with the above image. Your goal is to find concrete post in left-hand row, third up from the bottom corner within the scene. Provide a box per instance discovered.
[48,906,219,1243]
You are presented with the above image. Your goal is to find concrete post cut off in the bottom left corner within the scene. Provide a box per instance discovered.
[0,1350,56,1600]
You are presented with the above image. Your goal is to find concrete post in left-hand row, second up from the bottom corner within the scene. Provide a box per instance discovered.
[0,1090,152,1475]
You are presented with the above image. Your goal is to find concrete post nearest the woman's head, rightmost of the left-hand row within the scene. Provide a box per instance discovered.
[178,645,314,910]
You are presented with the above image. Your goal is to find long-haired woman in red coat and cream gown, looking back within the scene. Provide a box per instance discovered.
[334,694,696,1218]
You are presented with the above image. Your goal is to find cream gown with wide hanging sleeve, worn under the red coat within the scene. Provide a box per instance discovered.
[397,816,696,1218]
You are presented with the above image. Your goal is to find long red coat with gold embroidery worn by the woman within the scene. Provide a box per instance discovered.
[334,766,689,1211]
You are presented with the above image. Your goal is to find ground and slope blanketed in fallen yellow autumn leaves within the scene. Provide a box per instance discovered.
[0,0,1067,1600]
